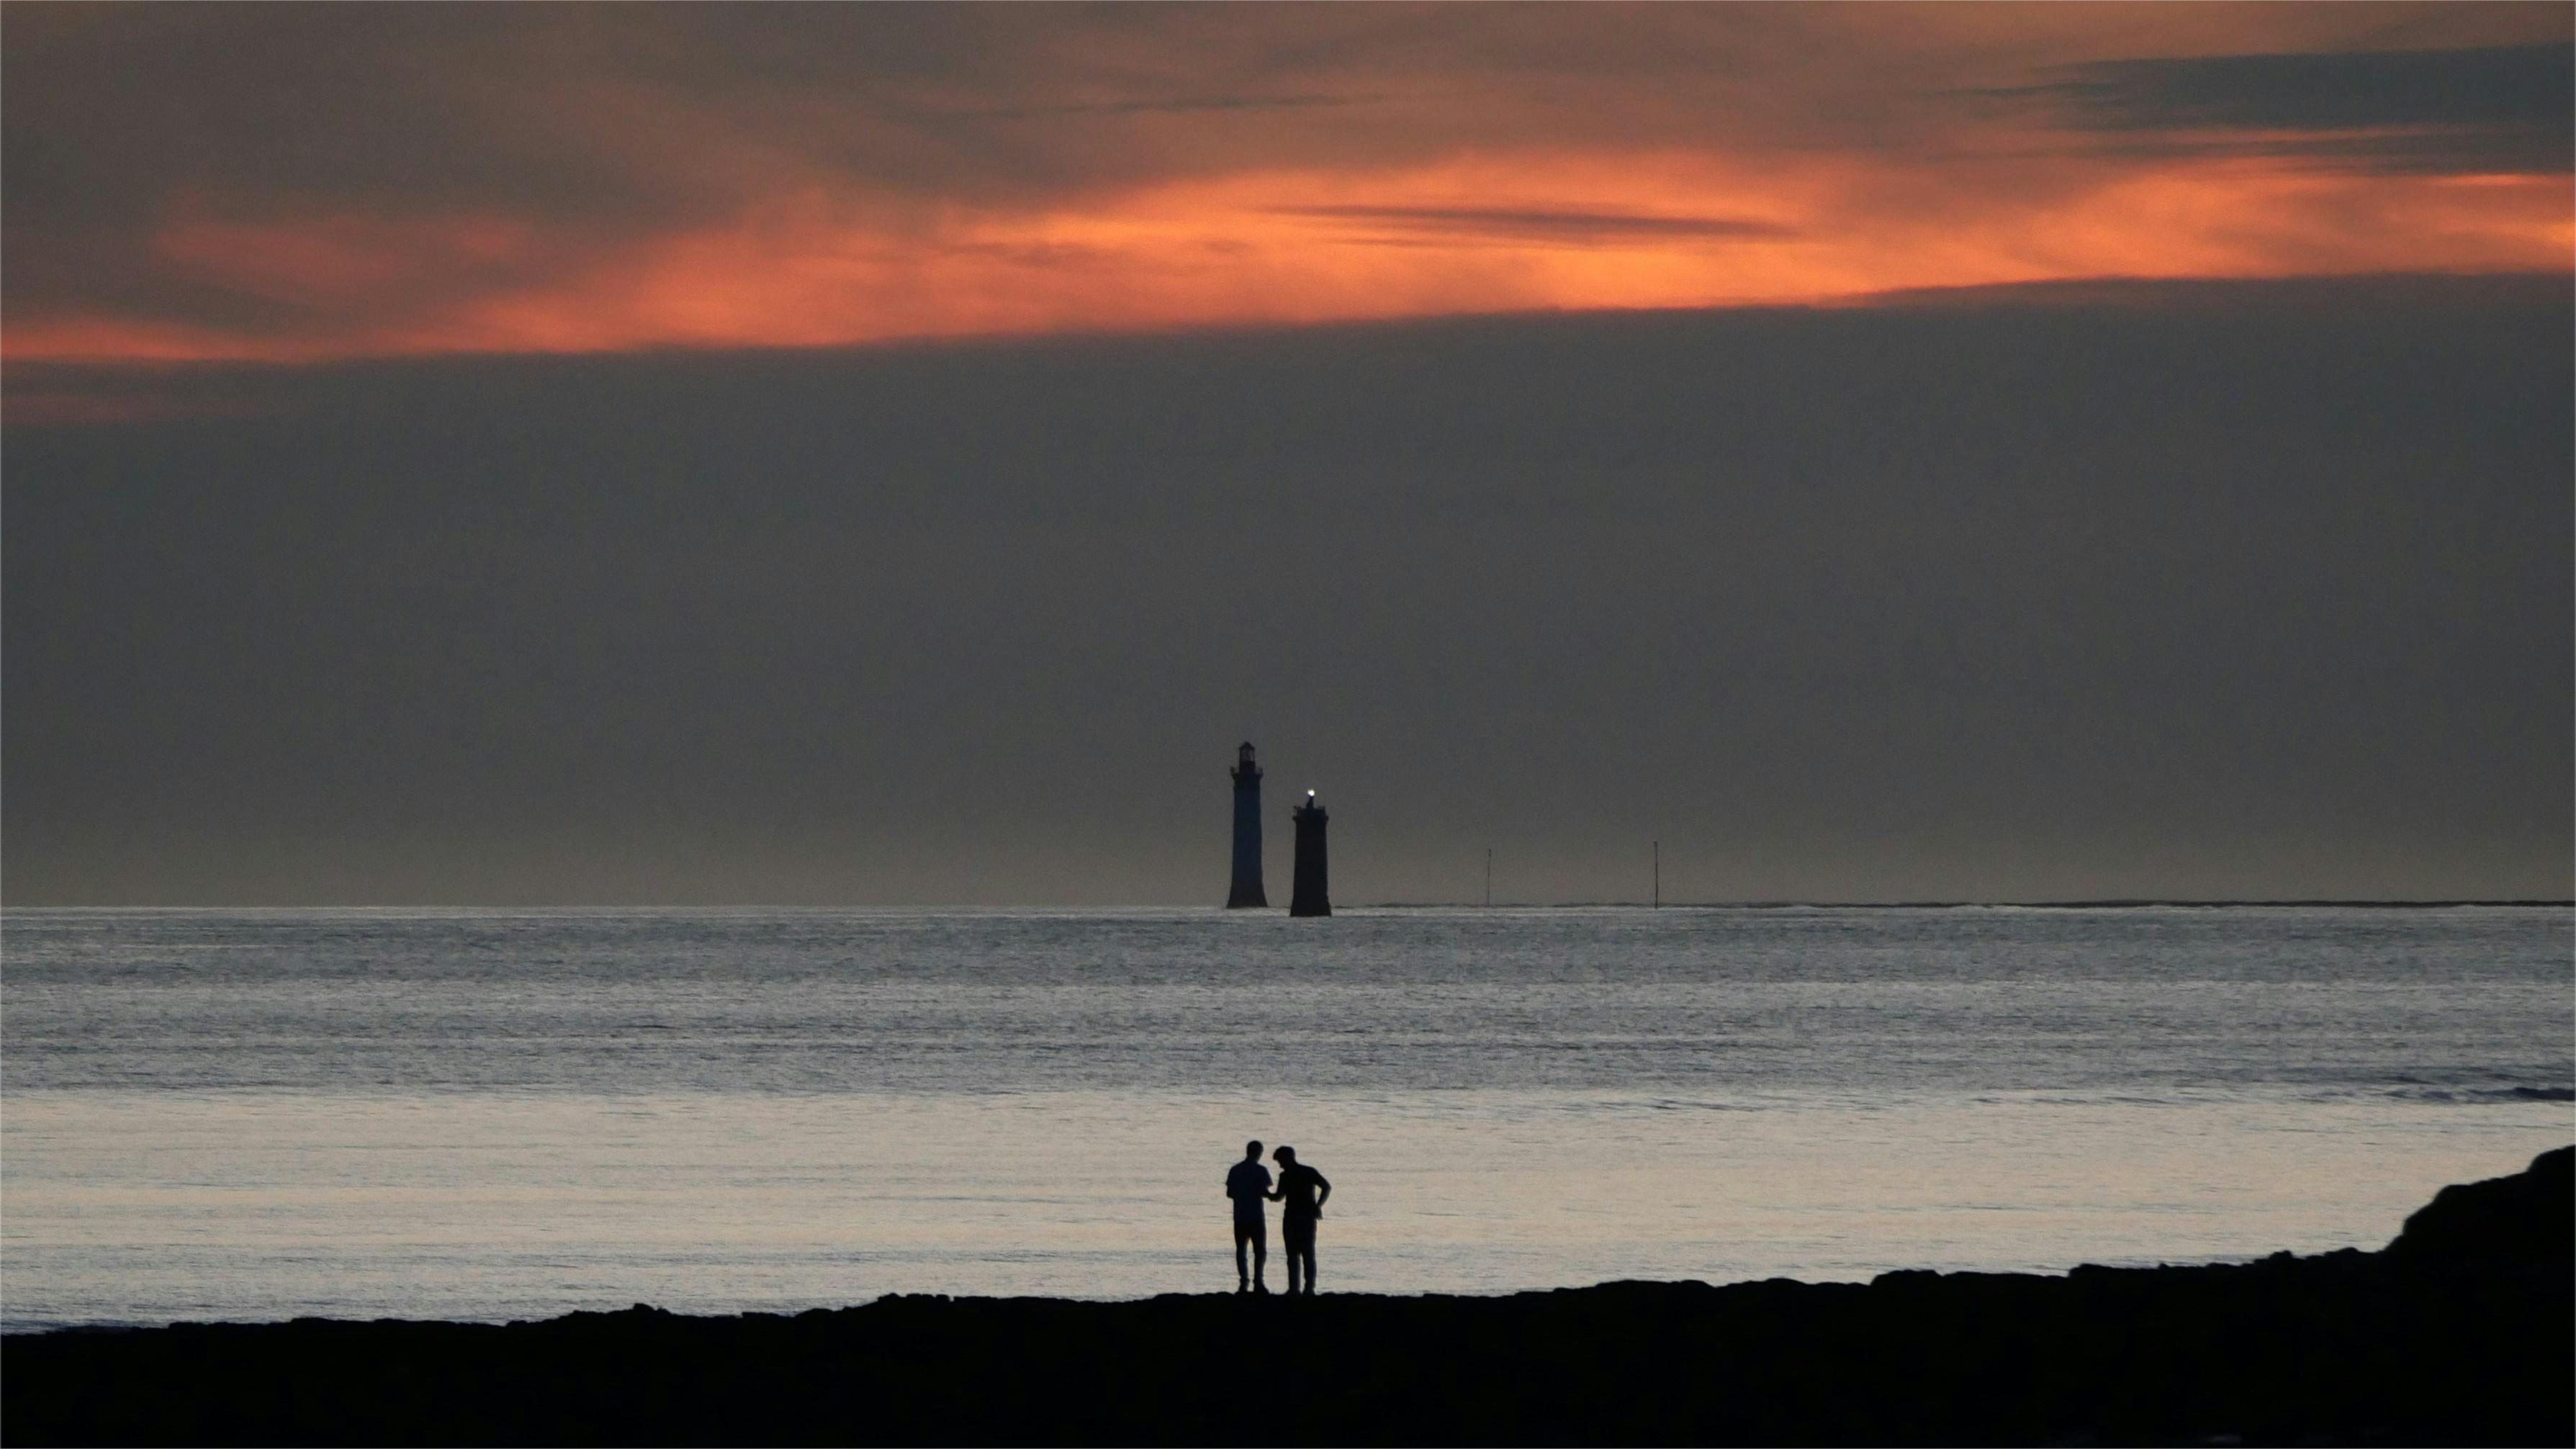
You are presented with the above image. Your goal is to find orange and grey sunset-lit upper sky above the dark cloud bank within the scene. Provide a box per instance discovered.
[5,5,2576,363]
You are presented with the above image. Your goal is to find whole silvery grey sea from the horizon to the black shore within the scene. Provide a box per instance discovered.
[0,906,2576,1331]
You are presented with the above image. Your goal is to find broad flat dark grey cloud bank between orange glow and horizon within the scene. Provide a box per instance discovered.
[0,276,2576,903]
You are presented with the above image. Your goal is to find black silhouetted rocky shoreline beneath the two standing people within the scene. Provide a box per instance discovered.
[0,1148,2576,1444]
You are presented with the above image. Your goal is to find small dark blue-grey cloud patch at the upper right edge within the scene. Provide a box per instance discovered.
[1999,44,2576,173]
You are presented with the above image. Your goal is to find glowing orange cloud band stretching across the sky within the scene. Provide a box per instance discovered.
[0,155,2576,363]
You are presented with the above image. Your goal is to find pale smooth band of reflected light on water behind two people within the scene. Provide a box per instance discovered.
[5,1091,2568,1325]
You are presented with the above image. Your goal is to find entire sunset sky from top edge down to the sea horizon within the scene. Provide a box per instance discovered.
[0,3,2576,900]
